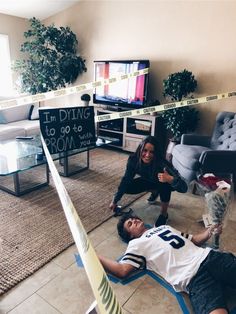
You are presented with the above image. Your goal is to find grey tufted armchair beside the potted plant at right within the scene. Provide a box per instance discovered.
[172,111,236,183]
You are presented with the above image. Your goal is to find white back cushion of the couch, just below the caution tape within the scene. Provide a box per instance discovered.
[0,104,31,123]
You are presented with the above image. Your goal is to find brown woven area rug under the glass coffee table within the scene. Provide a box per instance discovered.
[0,149,144,295]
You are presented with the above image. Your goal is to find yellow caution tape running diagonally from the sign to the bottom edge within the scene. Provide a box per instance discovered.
[41,135,122,314]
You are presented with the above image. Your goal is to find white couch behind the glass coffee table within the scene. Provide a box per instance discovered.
[0,104,40,141]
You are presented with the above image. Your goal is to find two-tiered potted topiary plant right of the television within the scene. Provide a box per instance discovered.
[161,69,199,160]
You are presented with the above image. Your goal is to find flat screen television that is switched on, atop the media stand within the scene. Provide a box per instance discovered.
[93,60,150,109]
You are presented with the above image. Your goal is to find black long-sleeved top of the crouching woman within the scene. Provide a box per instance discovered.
[113,155,188,204]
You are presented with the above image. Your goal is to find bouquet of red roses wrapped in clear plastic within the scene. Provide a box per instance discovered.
[190,173,234,249]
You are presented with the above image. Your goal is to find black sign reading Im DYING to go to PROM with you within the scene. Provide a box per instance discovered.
[39,106,96,154]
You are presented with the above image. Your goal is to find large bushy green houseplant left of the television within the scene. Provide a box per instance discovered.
[13,18,87,94]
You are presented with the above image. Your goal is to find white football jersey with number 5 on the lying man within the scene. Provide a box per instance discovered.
[120,225,210,292]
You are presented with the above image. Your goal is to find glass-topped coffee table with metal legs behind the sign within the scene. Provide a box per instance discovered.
[0,136,117,196]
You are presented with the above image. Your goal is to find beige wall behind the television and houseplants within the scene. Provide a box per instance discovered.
[0,0,236,133]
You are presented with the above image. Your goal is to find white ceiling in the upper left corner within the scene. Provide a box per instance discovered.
[0,0,81,20]
